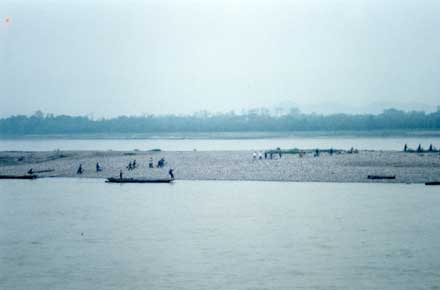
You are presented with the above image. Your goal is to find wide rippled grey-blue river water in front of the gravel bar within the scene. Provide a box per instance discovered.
[0,179,440,290]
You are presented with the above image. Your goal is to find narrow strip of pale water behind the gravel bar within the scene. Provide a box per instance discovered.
[0,135,440,151]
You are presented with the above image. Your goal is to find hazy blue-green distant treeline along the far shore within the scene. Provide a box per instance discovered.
[0,109,440,135]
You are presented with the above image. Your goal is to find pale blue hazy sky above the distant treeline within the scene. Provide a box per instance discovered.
[0,0,440,117]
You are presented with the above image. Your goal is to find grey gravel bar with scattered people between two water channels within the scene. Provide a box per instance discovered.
[0,151,440,183]
